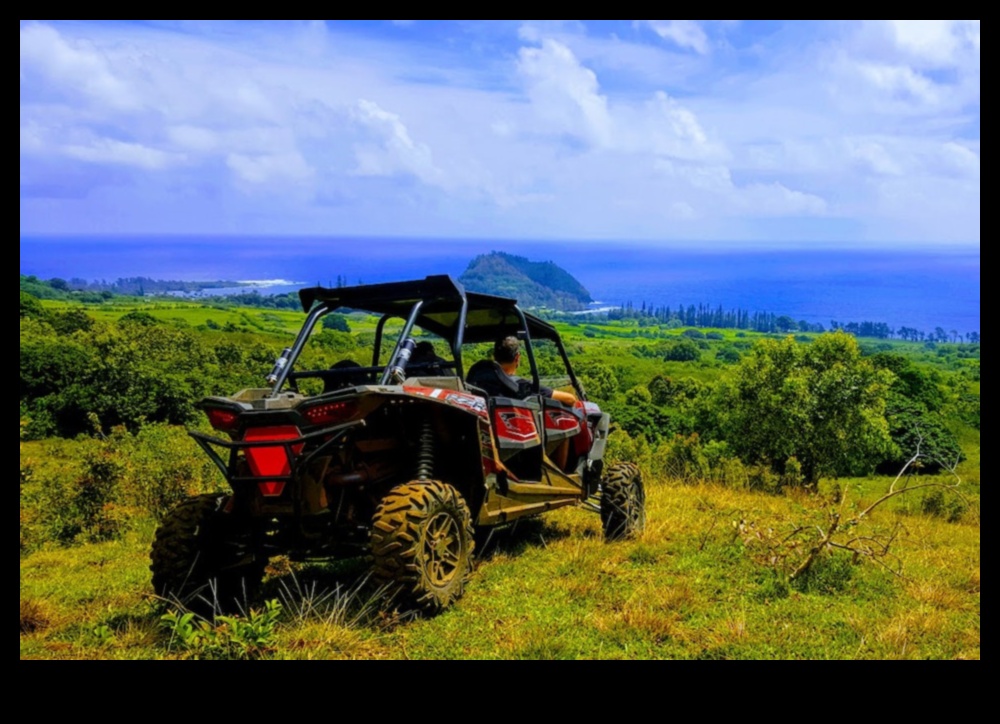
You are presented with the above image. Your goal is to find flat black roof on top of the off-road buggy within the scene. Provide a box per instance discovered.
[299,274,559,342]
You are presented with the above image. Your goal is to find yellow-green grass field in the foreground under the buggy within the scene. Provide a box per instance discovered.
[20,456,980,659]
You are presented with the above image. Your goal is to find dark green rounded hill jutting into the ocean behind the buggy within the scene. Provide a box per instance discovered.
[458,251,593,311]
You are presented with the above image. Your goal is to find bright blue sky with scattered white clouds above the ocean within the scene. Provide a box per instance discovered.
[20,20,980,245]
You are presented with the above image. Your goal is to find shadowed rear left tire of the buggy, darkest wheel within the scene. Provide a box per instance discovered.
[149,493,266,614]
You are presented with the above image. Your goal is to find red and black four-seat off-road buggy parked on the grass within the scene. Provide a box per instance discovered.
[150,276,645,613]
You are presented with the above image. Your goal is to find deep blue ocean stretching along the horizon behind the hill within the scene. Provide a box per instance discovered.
[20,236,980,334]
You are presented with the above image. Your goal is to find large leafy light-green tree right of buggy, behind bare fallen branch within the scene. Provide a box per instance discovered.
[713,332,893,483]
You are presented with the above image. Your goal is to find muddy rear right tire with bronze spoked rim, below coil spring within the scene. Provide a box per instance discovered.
[371,480,475,615]
